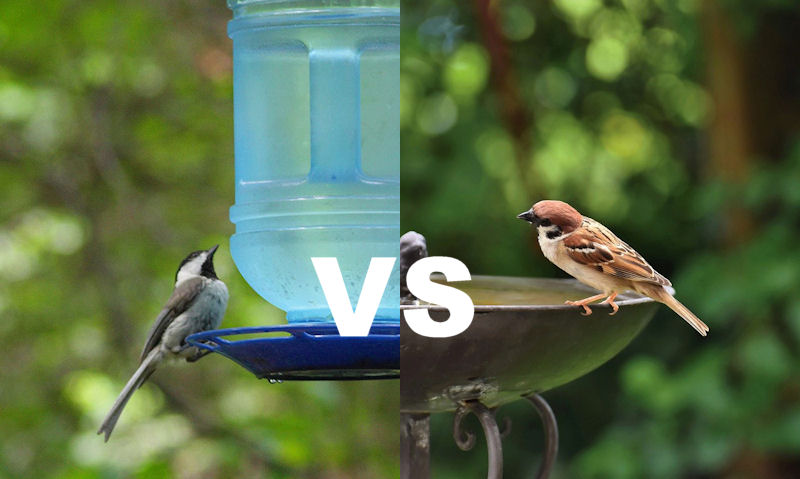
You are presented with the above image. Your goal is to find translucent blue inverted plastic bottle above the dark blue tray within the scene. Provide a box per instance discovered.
[228,0,400,323]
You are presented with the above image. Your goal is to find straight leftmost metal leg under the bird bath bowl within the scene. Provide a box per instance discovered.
[400,414,431,479]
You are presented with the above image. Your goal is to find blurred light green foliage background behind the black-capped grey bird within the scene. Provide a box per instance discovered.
[0,0,399,479]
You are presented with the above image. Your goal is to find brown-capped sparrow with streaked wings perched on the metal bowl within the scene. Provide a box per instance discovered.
[517,200,708,336]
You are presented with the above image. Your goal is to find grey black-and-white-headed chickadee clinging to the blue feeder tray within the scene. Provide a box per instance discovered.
[97,245,228,442]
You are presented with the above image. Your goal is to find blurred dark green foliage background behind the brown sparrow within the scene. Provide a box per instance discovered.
[401,0,800,479]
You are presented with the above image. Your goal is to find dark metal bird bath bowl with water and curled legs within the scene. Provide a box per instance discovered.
[400,276,657,479]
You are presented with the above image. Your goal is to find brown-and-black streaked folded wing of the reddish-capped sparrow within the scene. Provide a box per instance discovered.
[564,217,672,286]
